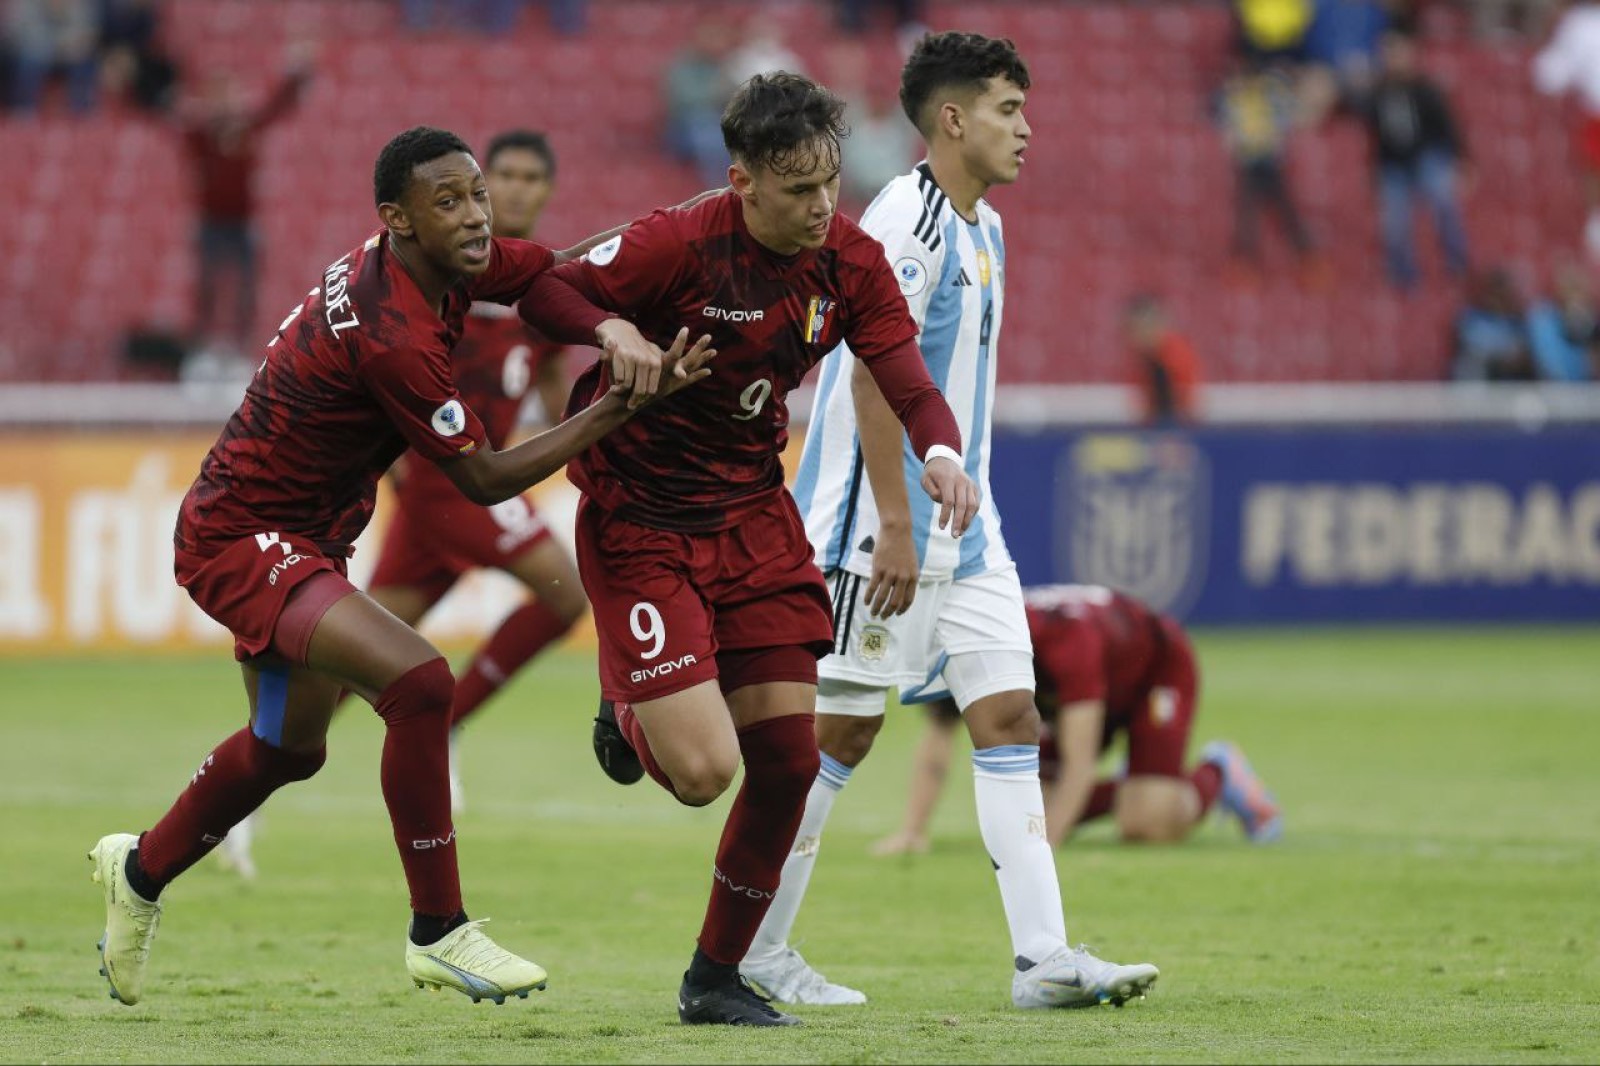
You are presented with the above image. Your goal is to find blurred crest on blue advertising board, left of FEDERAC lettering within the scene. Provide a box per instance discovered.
[1054,434,1211,613]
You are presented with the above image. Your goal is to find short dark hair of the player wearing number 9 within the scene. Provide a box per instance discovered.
[722,70,845,174]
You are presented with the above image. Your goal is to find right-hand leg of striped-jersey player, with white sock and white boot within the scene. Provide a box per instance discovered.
[946,685,1160,1008]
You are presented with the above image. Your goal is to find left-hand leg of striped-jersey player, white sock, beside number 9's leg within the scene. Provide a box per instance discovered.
[739,694,883,1007]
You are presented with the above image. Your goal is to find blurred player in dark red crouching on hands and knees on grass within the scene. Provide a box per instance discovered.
[874,584,1283,855]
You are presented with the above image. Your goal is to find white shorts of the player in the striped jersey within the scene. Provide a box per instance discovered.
[816,567,1034,717]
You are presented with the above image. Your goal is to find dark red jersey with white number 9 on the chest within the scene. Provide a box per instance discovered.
[554,190,934,533]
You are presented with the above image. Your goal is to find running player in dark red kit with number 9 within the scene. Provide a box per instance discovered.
[518,74,978,1026]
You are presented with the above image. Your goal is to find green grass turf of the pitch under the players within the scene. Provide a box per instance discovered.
[0,629,1600,1063]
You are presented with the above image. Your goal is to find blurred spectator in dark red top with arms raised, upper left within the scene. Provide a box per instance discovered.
[182,45,312,354]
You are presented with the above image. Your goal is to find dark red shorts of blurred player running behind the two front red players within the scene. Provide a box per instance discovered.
[368,487,550,599]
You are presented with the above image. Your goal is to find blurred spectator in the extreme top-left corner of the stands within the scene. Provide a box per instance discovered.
[6,0,99,114]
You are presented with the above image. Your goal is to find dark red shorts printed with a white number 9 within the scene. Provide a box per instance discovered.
[578,493,834,703]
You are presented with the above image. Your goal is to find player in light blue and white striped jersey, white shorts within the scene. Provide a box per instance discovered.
[741,32,1158,1007]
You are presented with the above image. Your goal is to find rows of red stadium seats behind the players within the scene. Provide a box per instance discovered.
[0,0,1582,383]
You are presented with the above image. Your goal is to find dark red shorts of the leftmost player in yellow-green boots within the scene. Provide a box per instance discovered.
[173,533,355,666]
